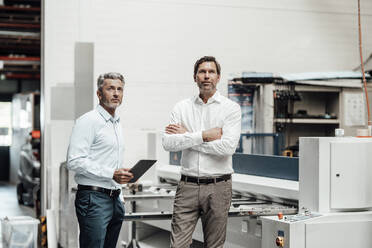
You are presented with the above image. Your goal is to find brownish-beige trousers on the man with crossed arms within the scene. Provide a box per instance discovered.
[171,179,232,248]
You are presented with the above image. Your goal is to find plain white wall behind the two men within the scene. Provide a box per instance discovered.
[44,0,372,222]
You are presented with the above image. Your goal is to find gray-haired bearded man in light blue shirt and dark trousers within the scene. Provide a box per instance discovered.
[67,72,133,248]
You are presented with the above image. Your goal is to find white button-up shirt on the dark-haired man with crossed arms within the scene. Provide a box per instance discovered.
[163,91,241,177]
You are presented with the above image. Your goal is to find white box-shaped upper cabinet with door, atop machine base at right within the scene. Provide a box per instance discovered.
[299,137,372,213]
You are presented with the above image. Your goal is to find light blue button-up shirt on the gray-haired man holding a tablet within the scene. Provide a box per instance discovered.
[67,105,124,189]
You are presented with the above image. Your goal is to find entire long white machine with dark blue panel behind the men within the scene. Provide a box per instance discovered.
[125,137,372,248]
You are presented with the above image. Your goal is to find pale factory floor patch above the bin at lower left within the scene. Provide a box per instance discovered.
[0,181,35,248]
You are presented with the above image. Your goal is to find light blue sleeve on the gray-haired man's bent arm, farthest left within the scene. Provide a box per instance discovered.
[67,119,115,179]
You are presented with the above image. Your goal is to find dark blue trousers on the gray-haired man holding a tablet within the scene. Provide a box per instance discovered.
[75,190,125,248]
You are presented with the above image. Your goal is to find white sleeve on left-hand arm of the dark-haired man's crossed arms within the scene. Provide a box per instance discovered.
[162,106,203,152]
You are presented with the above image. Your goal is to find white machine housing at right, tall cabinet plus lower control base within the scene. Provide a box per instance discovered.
[261,137,372,248]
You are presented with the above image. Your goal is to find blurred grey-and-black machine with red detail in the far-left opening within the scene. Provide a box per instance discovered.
[10,92,41,209]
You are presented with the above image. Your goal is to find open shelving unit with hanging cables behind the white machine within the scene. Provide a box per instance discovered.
[228,71,372,157]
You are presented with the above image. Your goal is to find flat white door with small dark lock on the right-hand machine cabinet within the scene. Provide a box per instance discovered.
[330,140,372,210]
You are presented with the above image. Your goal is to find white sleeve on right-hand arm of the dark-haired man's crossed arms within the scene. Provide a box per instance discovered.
[192,104,241,156]
